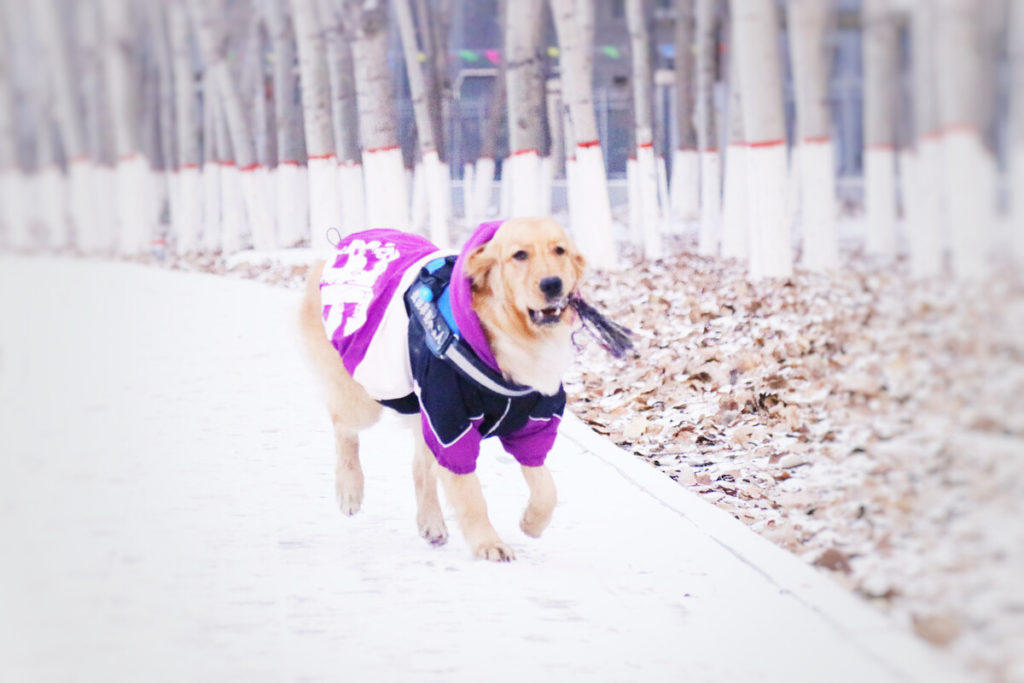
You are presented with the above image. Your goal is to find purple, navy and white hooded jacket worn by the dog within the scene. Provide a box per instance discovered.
[321,221,565,474]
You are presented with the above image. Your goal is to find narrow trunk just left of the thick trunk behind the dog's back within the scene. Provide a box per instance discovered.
[317,0,366,234]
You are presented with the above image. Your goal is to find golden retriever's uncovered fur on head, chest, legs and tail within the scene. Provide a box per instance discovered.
[300,218,585,561]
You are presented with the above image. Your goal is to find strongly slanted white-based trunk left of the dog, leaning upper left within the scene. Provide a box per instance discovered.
[187,0,274,251]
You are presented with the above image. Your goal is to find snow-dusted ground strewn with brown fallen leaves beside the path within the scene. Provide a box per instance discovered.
[173,249,1024,681]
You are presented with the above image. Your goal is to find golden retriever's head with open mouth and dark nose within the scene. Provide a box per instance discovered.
[464,218,586,335]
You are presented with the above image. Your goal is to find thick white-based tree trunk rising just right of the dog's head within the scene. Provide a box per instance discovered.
[551,0,618,268]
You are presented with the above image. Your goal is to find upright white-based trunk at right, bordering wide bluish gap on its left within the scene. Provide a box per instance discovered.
[861,0,899,259]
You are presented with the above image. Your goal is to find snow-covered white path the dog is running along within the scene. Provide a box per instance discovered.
[0,255,967,681]
